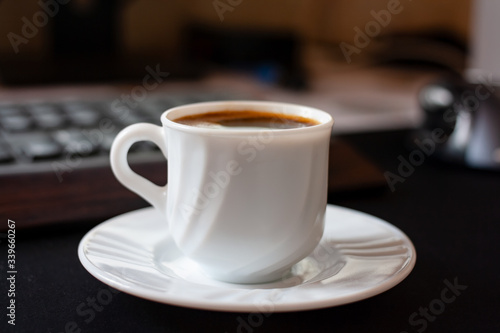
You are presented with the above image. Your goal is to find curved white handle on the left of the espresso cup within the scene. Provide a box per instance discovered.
[110,123,167,214]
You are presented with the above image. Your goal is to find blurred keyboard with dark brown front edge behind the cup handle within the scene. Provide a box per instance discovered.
[0,92,249,227]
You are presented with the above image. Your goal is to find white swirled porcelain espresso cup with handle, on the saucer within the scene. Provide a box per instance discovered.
[111,101,333,283]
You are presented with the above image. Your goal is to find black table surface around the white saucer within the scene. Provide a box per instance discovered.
[0,131,500,333]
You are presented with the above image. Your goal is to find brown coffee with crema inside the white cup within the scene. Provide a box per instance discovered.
[173,110,320,129]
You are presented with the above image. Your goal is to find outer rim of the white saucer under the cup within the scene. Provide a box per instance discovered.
[78,204,417,313]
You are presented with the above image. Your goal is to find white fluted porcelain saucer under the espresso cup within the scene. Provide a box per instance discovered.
[78,205,416,312]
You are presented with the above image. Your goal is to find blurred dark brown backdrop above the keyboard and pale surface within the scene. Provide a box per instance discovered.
[0,0,471,83]
